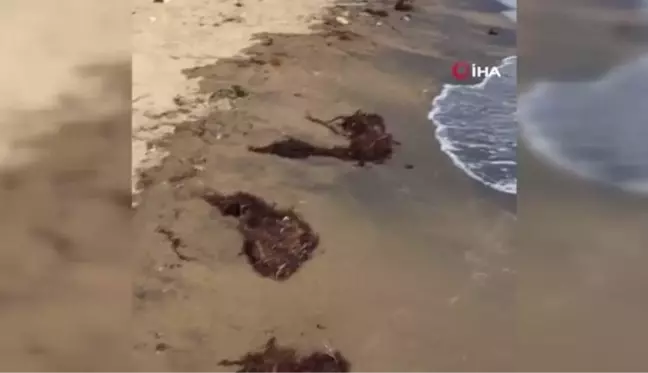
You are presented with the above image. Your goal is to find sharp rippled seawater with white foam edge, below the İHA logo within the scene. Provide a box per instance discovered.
[428,0,518,194]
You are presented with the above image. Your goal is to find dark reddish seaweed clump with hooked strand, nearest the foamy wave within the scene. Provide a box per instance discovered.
[249,110,399,166]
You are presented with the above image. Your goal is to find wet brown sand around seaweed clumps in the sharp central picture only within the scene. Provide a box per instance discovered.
[134,2,515,373]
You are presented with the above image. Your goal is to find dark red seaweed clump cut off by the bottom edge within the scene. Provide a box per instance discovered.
[220,338,350,373]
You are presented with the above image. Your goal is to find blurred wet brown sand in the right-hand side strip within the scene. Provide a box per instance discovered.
[516,0,648,373]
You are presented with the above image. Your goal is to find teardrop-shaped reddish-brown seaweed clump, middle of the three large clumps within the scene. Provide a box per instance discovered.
[204,192,319,280]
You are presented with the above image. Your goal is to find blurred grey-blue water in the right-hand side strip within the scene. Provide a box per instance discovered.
[517,1,648,194]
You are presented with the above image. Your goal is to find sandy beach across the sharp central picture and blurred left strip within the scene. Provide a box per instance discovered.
[0,0,514,373]
